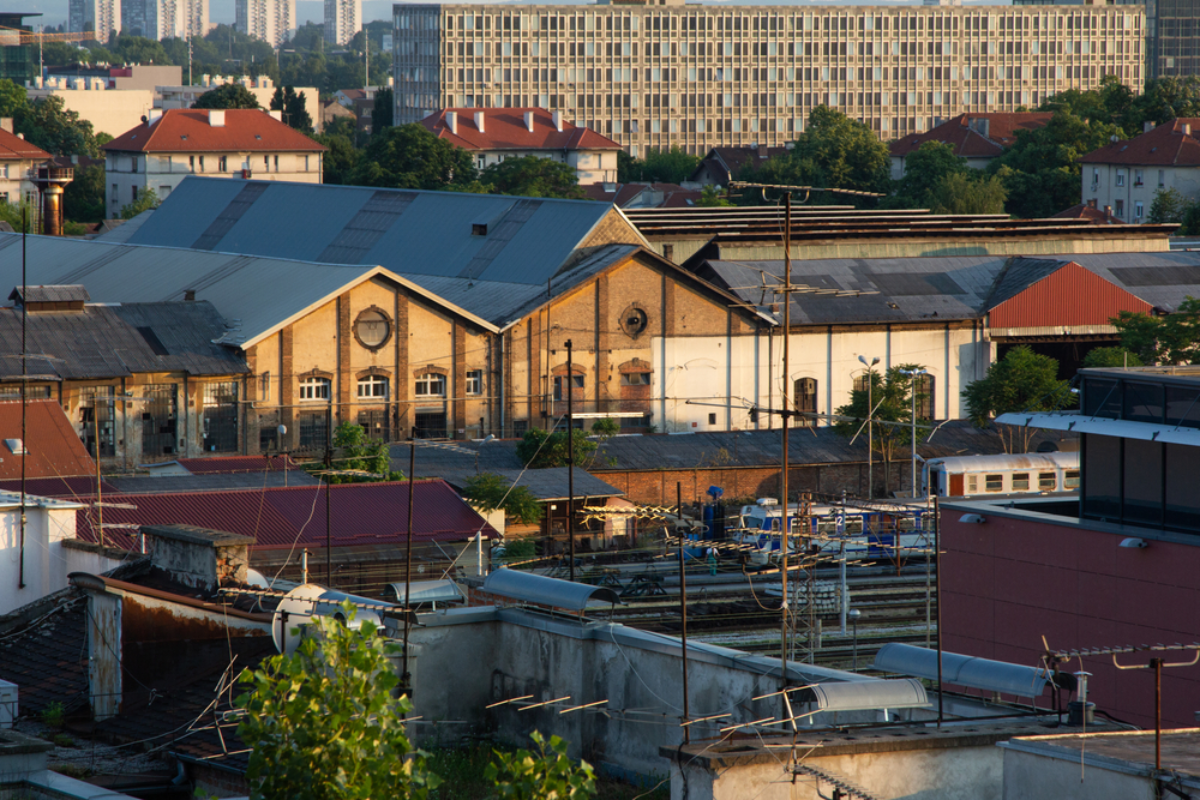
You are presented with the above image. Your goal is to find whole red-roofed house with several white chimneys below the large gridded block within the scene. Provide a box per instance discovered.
[421,108,622,186]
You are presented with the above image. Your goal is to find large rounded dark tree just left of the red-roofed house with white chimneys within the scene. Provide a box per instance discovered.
[348,122,476,191]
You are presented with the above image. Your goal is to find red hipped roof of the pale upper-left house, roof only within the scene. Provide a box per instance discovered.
[104,108,325,152]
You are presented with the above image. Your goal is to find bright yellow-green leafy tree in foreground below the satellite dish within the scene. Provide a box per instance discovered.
[235,603,440,800]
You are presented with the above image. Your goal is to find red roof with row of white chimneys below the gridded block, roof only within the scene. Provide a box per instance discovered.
[421,108,620,150]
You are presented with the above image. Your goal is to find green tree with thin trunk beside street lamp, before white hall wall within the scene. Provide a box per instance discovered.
[834,363,929,493]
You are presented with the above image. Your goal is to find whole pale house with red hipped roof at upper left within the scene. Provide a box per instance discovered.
[104,108,325,217]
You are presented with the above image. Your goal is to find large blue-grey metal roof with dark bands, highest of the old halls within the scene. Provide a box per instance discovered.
[117,176,641,285]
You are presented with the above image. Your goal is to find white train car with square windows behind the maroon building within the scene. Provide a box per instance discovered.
[923,452,1079,498]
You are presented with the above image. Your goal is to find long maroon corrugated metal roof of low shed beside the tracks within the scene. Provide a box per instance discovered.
[78,480,498,549]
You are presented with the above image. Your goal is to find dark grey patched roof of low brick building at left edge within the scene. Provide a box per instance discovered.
[0,302,248,379]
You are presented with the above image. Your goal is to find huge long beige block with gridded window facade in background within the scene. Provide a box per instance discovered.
[393,0,1145,155]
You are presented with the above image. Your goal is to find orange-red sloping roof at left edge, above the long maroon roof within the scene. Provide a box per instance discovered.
[0,399,96,480]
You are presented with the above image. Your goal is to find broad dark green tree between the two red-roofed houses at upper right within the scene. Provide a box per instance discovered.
[988,112,1124,218]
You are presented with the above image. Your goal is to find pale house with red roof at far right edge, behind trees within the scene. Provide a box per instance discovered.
[1080,118,1200,223]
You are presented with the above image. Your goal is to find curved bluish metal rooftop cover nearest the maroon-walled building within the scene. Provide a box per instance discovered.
[872,642,1050,697]
